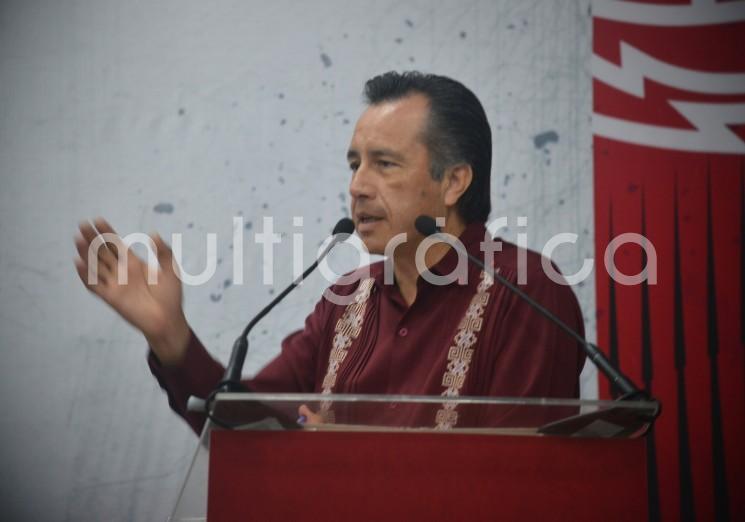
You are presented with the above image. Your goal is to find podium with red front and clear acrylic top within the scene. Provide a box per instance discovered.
[170,393,658,522]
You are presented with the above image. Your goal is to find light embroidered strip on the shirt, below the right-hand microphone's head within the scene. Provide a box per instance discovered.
[435,271,494,430]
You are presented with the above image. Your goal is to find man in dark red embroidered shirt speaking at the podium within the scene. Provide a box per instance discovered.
[76,72,584,431]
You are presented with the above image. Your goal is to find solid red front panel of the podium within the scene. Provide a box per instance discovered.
[207,431,647,522]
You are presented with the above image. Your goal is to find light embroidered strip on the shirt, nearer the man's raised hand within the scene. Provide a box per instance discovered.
[320,278,375,423]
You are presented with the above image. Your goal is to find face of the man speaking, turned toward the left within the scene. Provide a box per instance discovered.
[347,94,446,254]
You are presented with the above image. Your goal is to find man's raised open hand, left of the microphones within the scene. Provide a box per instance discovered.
[75,218,190,364]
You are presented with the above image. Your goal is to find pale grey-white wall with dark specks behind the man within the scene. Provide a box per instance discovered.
[0,0,595,521]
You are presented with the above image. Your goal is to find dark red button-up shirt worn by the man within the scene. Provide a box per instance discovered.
[149,223,585,431]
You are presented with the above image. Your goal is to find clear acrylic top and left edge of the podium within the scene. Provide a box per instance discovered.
[170,393,659,522]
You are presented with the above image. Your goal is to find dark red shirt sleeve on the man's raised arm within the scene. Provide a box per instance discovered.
[148,290,329,434]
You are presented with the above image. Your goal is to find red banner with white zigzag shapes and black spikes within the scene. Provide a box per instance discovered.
[592,1,745,520]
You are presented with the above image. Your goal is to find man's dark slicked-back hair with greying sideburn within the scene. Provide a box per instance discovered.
[364,71,491,223]
